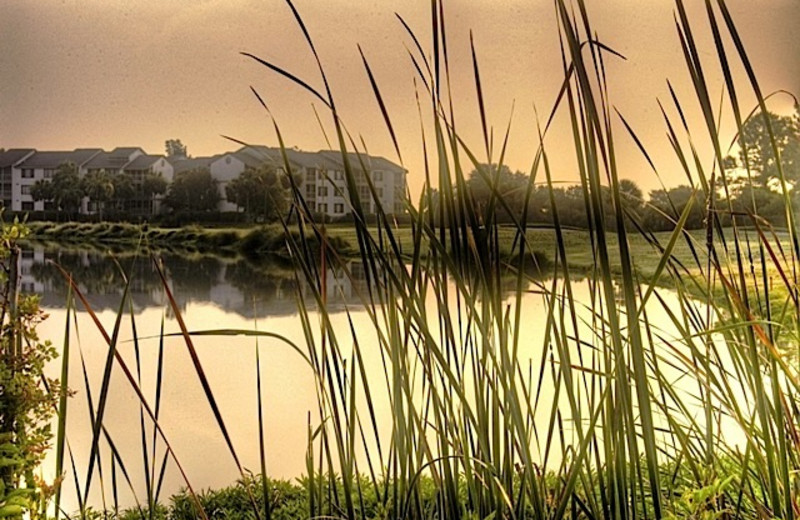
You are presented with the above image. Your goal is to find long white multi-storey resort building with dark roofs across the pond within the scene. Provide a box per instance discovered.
[0,146,407,219]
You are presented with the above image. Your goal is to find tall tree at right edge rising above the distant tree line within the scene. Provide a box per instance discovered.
[725,107,800,189]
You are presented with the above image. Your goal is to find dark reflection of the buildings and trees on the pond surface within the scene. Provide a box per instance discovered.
[21,245,542,318]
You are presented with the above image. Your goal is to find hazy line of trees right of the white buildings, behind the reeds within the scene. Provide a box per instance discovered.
[438,108,800,231]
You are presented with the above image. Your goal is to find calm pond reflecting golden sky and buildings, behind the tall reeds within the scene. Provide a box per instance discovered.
[26,247,732,511]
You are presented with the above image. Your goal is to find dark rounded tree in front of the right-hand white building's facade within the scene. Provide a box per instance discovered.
[225,165,289,220]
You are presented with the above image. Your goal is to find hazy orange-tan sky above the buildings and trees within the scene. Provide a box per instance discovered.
[0,0,800,193]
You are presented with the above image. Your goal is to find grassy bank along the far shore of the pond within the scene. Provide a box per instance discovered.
[25,217,791,294]
